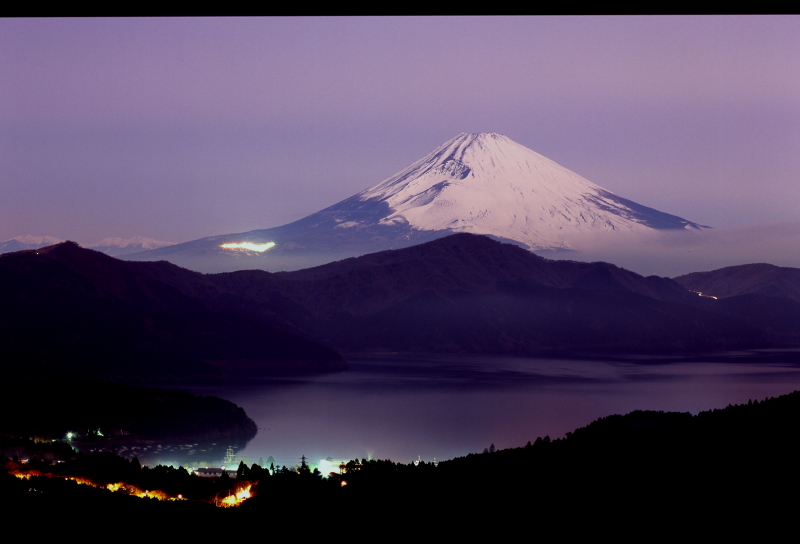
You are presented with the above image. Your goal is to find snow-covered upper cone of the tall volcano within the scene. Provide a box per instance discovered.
[350,133,700,249]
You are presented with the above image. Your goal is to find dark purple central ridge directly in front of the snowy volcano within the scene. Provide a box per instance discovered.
[188,234,769,354]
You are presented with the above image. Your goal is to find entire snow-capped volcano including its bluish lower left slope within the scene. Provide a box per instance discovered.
[125,133,707,272]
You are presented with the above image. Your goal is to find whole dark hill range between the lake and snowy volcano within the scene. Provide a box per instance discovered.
[0,234,784,381]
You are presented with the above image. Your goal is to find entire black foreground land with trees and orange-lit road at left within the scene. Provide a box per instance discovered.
[6,392,800,535]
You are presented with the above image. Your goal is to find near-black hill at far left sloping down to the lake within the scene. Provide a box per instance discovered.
[0,242,345,382]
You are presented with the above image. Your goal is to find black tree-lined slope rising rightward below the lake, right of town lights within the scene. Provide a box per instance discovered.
[243,392,800,537]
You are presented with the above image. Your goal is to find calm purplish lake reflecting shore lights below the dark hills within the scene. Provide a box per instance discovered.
[158,352,800,466]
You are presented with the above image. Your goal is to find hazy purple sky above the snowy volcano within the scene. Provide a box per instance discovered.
[0,16,800,243]
